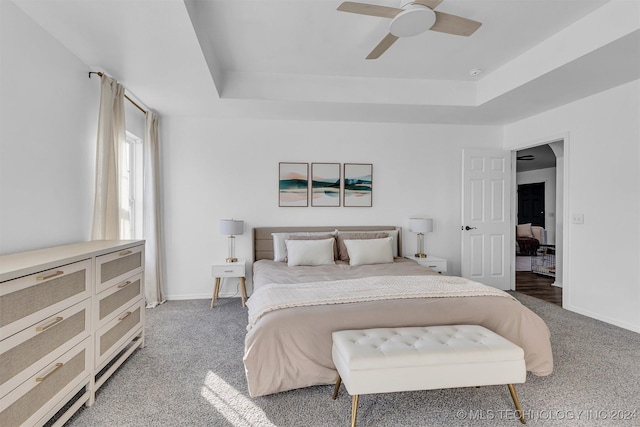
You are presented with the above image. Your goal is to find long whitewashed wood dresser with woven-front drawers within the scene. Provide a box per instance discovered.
[0,241,144,427]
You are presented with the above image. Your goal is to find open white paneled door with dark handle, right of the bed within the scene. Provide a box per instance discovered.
[461,149,514,290]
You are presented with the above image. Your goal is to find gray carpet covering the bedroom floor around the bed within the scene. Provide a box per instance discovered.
[68,293,640,427]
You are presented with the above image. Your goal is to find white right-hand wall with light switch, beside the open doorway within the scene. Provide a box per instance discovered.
[504,80,640,332]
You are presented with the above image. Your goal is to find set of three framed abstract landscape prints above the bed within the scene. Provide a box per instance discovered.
[278,163,373,207]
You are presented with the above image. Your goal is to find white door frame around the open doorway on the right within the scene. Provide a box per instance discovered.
[507,131,571,308]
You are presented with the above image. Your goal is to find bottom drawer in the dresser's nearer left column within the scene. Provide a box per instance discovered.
[0,339,90,427]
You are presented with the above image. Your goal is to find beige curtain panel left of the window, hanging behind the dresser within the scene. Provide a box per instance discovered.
[91,74,125,240]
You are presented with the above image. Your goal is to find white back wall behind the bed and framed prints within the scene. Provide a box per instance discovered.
[161,118,502,299]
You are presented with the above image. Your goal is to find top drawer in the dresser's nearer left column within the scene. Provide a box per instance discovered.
[0,260,92,339]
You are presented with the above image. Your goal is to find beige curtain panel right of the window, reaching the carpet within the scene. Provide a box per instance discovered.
[143,111,165,308]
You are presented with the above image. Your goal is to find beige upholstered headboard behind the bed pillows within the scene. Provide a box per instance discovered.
[253,225,402,261]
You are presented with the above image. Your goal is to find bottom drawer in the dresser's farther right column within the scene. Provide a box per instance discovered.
[95,300,144,371]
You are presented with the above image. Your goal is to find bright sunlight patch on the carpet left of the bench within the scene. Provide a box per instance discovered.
[200,371,276,427]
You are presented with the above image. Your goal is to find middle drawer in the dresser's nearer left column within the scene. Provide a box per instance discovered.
[0,300,91,397]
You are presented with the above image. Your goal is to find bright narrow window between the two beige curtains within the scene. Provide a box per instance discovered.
[120,131,143,239]
